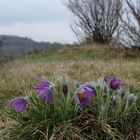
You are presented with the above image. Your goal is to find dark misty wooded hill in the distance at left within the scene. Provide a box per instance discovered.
[0,35,63,62]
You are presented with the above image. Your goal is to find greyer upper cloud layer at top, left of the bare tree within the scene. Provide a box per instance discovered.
[0,0,70,23]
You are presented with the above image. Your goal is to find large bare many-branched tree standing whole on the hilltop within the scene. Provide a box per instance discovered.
[65,0,122,44]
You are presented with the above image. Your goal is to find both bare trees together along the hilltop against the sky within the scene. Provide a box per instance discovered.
[64,0,140,49]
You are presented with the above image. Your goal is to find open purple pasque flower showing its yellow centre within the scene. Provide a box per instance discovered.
[74,82,96,110]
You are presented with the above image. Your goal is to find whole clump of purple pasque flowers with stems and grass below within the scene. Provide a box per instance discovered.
[5,76,139,139]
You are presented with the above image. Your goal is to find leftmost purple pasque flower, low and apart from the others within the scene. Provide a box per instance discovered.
[8,97,26,112]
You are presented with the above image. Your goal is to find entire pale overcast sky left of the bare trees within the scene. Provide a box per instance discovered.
[0,0,76,43]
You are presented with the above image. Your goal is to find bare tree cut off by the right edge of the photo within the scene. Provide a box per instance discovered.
[121,0,140,48]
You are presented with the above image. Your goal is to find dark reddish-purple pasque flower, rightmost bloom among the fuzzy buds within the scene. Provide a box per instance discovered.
[105,77,123,90]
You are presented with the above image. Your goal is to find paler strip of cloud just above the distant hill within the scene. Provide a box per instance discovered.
[0,22,75,43]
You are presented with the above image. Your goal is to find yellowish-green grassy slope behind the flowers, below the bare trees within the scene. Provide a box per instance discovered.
[0,45,140,139]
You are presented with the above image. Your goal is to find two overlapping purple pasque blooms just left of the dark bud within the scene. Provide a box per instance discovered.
[35,79,53,104]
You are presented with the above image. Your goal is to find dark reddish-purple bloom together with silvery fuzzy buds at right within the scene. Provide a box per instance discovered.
[98,76,137,110]
